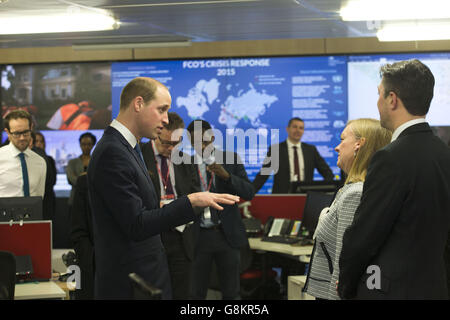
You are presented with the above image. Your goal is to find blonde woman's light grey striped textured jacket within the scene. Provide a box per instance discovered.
[306,182,363,300]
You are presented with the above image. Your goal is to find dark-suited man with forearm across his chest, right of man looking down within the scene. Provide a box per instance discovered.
[187,120,255,300]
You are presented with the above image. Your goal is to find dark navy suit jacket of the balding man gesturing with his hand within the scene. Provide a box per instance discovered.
[88,127,199,299]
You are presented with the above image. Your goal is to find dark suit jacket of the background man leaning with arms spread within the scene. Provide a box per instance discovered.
[253,141,334,193]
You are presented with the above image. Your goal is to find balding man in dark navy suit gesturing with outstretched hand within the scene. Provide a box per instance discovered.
[87,77,243,299]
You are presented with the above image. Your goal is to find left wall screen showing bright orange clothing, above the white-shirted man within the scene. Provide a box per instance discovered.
[0,63,111,197]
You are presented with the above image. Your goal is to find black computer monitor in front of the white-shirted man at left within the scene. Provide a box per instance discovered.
[0,197,43,222]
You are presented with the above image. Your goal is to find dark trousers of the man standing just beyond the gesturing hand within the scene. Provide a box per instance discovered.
[192,228,241,300]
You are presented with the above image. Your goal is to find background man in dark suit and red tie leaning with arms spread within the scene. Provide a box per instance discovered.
[253,118,334,193]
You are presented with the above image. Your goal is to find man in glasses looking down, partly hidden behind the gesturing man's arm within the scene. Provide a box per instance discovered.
[142,112,201,300]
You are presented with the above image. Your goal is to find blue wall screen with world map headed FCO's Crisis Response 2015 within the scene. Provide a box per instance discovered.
[111,56,348,193]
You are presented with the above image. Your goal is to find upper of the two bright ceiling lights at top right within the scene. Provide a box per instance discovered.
[340,0,450,21]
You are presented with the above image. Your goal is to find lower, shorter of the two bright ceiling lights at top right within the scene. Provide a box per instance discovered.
[377,23,450,41]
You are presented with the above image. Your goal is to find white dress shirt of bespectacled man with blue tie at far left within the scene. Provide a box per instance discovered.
[0,142,47,198]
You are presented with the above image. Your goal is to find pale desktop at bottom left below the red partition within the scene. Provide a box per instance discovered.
[14,281,66,300]
